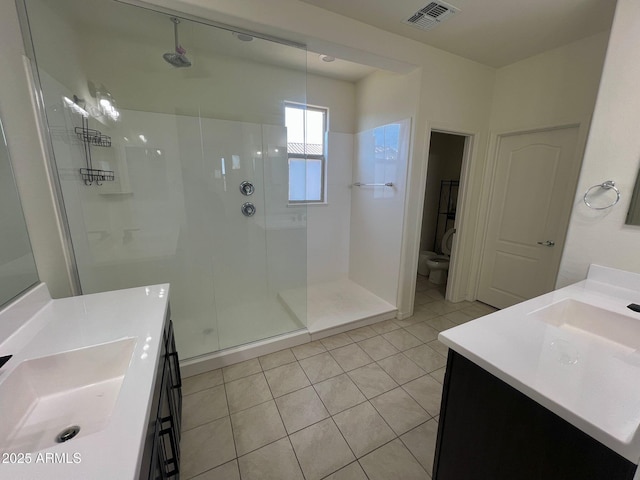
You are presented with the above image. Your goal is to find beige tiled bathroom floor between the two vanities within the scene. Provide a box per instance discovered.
[181,277,494,480]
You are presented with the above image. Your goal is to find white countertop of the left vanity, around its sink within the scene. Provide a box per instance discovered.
[0,284,169,480]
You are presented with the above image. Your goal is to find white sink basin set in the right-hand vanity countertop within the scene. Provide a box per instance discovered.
[531,299,640,350]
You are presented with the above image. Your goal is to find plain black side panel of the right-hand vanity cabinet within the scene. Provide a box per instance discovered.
[433,350,637,480]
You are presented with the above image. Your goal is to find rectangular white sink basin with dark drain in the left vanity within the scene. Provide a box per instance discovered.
[0,338,136,453]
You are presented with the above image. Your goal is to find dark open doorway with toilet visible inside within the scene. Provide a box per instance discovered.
[414,130,468,306]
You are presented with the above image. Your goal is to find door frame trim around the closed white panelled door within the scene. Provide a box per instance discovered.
[469,119,591,299]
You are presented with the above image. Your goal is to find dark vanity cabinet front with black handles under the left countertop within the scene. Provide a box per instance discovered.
[139,318,182,480]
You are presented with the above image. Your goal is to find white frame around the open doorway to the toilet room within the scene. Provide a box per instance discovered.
[397,121,480,319]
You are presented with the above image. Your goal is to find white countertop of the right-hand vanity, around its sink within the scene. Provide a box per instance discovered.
[438,265,640,464]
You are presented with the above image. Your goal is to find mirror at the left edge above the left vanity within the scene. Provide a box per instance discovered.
[0,121,38,306]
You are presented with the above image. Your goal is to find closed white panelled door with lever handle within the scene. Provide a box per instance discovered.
[478,127,581,308]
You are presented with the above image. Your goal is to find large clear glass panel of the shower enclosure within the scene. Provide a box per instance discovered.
[25,0,307,358]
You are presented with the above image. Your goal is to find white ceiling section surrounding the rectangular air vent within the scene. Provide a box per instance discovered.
[298,0,616,68]
